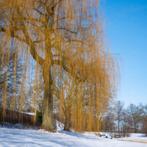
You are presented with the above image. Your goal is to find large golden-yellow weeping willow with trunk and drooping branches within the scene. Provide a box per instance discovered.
[0,0,115,131]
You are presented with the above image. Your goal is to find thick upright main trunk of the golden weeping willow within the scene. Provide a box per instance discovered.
[42,64,56,131]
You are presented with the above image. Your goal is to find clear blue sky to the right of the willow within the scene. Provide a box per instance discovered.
[100,0,147,105]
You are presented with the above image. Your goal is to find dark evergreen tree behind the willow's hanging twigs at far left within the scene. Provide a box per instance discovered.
[0,52,23,109]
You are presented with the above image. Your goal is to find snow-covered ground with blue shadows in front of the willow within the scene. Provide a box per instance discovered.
[0,127,147,147]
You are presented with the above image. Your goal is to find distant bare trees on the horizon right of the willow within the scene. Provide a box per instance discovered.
[101,101,147,134]
